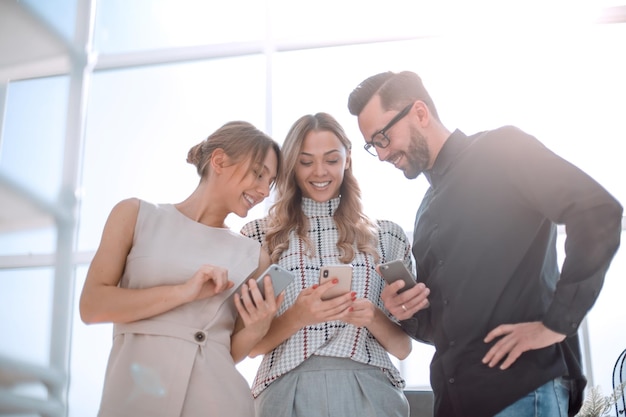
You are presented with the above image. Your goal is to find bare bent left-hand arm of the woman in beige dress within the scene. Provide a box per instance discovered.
[80,199,233,324]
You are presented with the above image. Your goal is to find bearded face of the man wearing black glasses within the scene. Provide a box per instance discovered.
[358,96,431,179]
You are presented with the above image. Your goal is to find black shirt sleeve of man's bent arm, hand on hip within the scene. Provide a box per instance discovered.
[492,128,623,335]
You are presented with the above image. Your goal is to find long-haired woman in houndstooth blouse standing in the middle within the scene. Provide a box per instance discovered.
[242,113,412,417]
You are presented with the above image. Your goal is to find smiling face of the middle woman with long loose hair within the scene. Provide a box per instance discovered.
[295,130,350,202]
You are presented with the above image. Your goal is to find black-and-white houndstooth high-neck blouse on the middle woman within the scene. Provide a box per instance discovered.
[241,197,412,398]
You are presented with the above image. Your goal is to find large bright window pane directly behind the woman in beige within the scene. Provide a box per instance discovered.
[79,56,265,250]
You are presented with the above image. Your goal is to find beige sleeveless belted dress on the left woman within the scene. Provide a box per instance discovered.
[98,201,260,417]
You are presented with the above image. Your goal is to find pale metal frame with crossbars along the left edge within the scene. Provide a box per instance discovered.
[0,0,95,417]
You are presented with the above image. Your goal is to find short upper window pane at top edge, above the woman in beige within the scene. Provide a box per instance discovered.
[95,0,265,53]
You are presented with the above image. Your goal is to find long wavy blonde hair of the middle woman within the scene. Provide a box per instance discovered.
[265,113,379,263]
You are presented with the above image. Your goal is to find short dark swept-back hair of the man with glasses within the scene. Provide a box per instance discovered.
[348,71,439,120]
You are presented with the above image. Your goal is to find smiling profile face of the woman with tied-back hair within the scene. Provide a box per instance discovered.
[224,150,278,217]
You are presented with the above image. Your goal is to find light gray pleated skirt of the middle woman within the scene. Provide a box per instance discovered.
[254,356,409,417]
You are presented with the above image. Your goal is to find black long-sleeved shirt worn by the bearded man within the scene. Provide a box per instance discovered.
[402,127,622,417]
